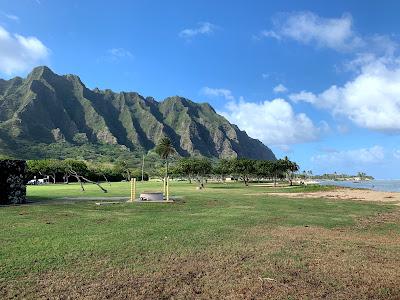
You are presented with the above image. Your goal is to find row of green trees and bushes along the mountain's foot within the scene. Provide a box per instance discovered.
[26,155,298,187]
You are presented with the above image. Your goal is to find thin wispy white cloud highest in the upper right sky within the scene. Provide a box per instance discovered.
[261,11,364,51]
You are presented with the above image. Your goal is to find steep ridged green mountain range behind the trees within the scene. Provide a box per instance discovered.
[0,66,275,159]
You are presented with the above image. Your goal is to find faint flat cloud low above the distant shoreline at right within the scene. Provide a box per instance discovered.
[311,146,385,167]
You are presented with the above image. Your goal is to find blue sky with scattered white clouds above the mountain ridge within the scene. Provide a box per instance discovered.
[0,0,400,179]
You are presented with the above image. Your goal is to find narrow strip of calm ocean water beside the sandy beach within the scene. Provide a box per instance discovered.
[319,180,400,192]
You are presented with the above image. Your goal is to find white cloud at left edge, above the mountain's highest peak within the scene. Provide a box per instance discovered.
[0,26,50,75]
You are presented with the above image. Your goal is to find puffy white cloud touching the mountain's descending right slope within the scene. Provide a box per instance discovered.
[221,99,320,148]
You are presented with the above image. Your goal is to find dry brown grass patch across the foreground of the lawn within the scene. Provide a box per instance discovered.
[0,218,400,299]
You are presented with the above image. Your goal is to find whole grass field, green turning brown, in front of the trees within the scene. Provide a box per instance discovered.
[0,182,400,299]
